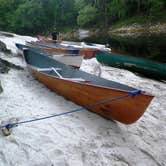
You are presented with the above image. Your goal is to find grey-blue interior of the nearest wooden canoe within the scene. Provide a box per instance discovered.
[25,50,136,91]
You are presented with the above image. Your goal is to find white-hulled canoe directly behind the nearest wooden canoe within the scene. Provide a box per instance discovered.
[16,43,83,68]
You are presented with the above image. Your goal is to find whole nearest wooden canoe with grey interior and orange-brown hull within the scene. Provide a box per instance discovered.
[24,49,153,124]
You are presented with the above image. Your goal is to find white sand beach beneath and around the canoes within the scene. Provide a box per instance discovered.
[0,35,166,166]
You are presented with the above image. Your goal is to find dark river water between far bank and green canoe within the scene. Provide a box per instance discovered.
[80,34,166,63]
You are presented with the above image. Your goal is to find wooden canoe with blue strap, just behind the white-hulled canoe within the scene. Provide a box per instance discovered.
[26,41,100,59]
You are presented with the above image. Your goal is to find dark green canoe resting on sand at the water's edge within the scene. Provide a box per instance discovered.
[96,53,166,80]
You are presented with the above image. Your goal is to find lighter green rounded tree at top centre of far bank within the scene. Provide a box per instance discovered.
[77,5,97,26]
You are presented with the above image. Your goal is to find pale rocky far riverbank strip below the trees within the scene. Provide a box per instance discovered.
[61,22,166,40]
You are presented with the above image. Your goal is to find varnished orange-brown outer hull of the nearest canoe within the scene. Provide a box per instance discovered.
[25,49,153,124]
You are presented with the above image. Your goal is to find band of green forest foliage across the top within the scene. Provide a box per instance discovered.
[0,0,166,34]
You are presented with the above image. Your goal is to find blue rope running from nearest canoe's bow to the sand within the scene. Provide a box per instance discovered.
[0,90,145,130]
